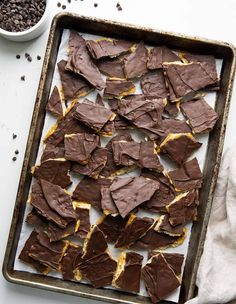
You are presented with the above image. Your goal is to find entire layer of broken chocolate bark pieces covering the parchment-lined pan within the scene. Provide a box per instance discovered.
[19,31,220,303]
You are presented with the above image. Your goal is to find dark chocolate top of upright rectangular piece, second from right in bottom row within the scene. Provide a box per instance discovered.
[115,252,143,293]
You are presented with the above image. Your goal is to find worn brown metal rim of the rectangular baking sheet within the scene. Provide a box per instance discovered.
[3,13,235,303]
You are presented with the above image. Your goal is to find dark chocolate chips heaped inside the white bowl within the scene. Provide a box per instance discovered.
[0,0,46,32]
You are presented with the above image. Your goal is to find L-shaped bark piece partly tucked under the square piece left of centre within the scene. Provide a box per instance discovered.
[71,148,107,179]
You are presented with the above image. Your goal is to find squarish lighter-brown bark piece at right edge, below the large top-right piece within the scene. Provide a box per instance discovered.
[181,98,218,134]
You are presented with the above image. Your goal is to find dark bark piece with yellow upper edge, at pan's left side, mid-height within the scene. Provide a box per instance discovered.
[32,158,72,188]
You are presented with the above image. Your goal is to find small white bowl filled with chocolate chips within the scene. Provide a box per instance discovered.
[0,0,49,42]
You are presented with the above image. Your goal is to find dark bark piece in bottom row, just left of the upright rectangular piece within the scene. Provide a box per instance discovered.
[79,252,117,288]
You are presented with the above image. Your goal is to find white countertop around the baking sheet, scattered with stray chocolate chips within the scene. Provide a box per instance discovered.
[0,0,236,304]
